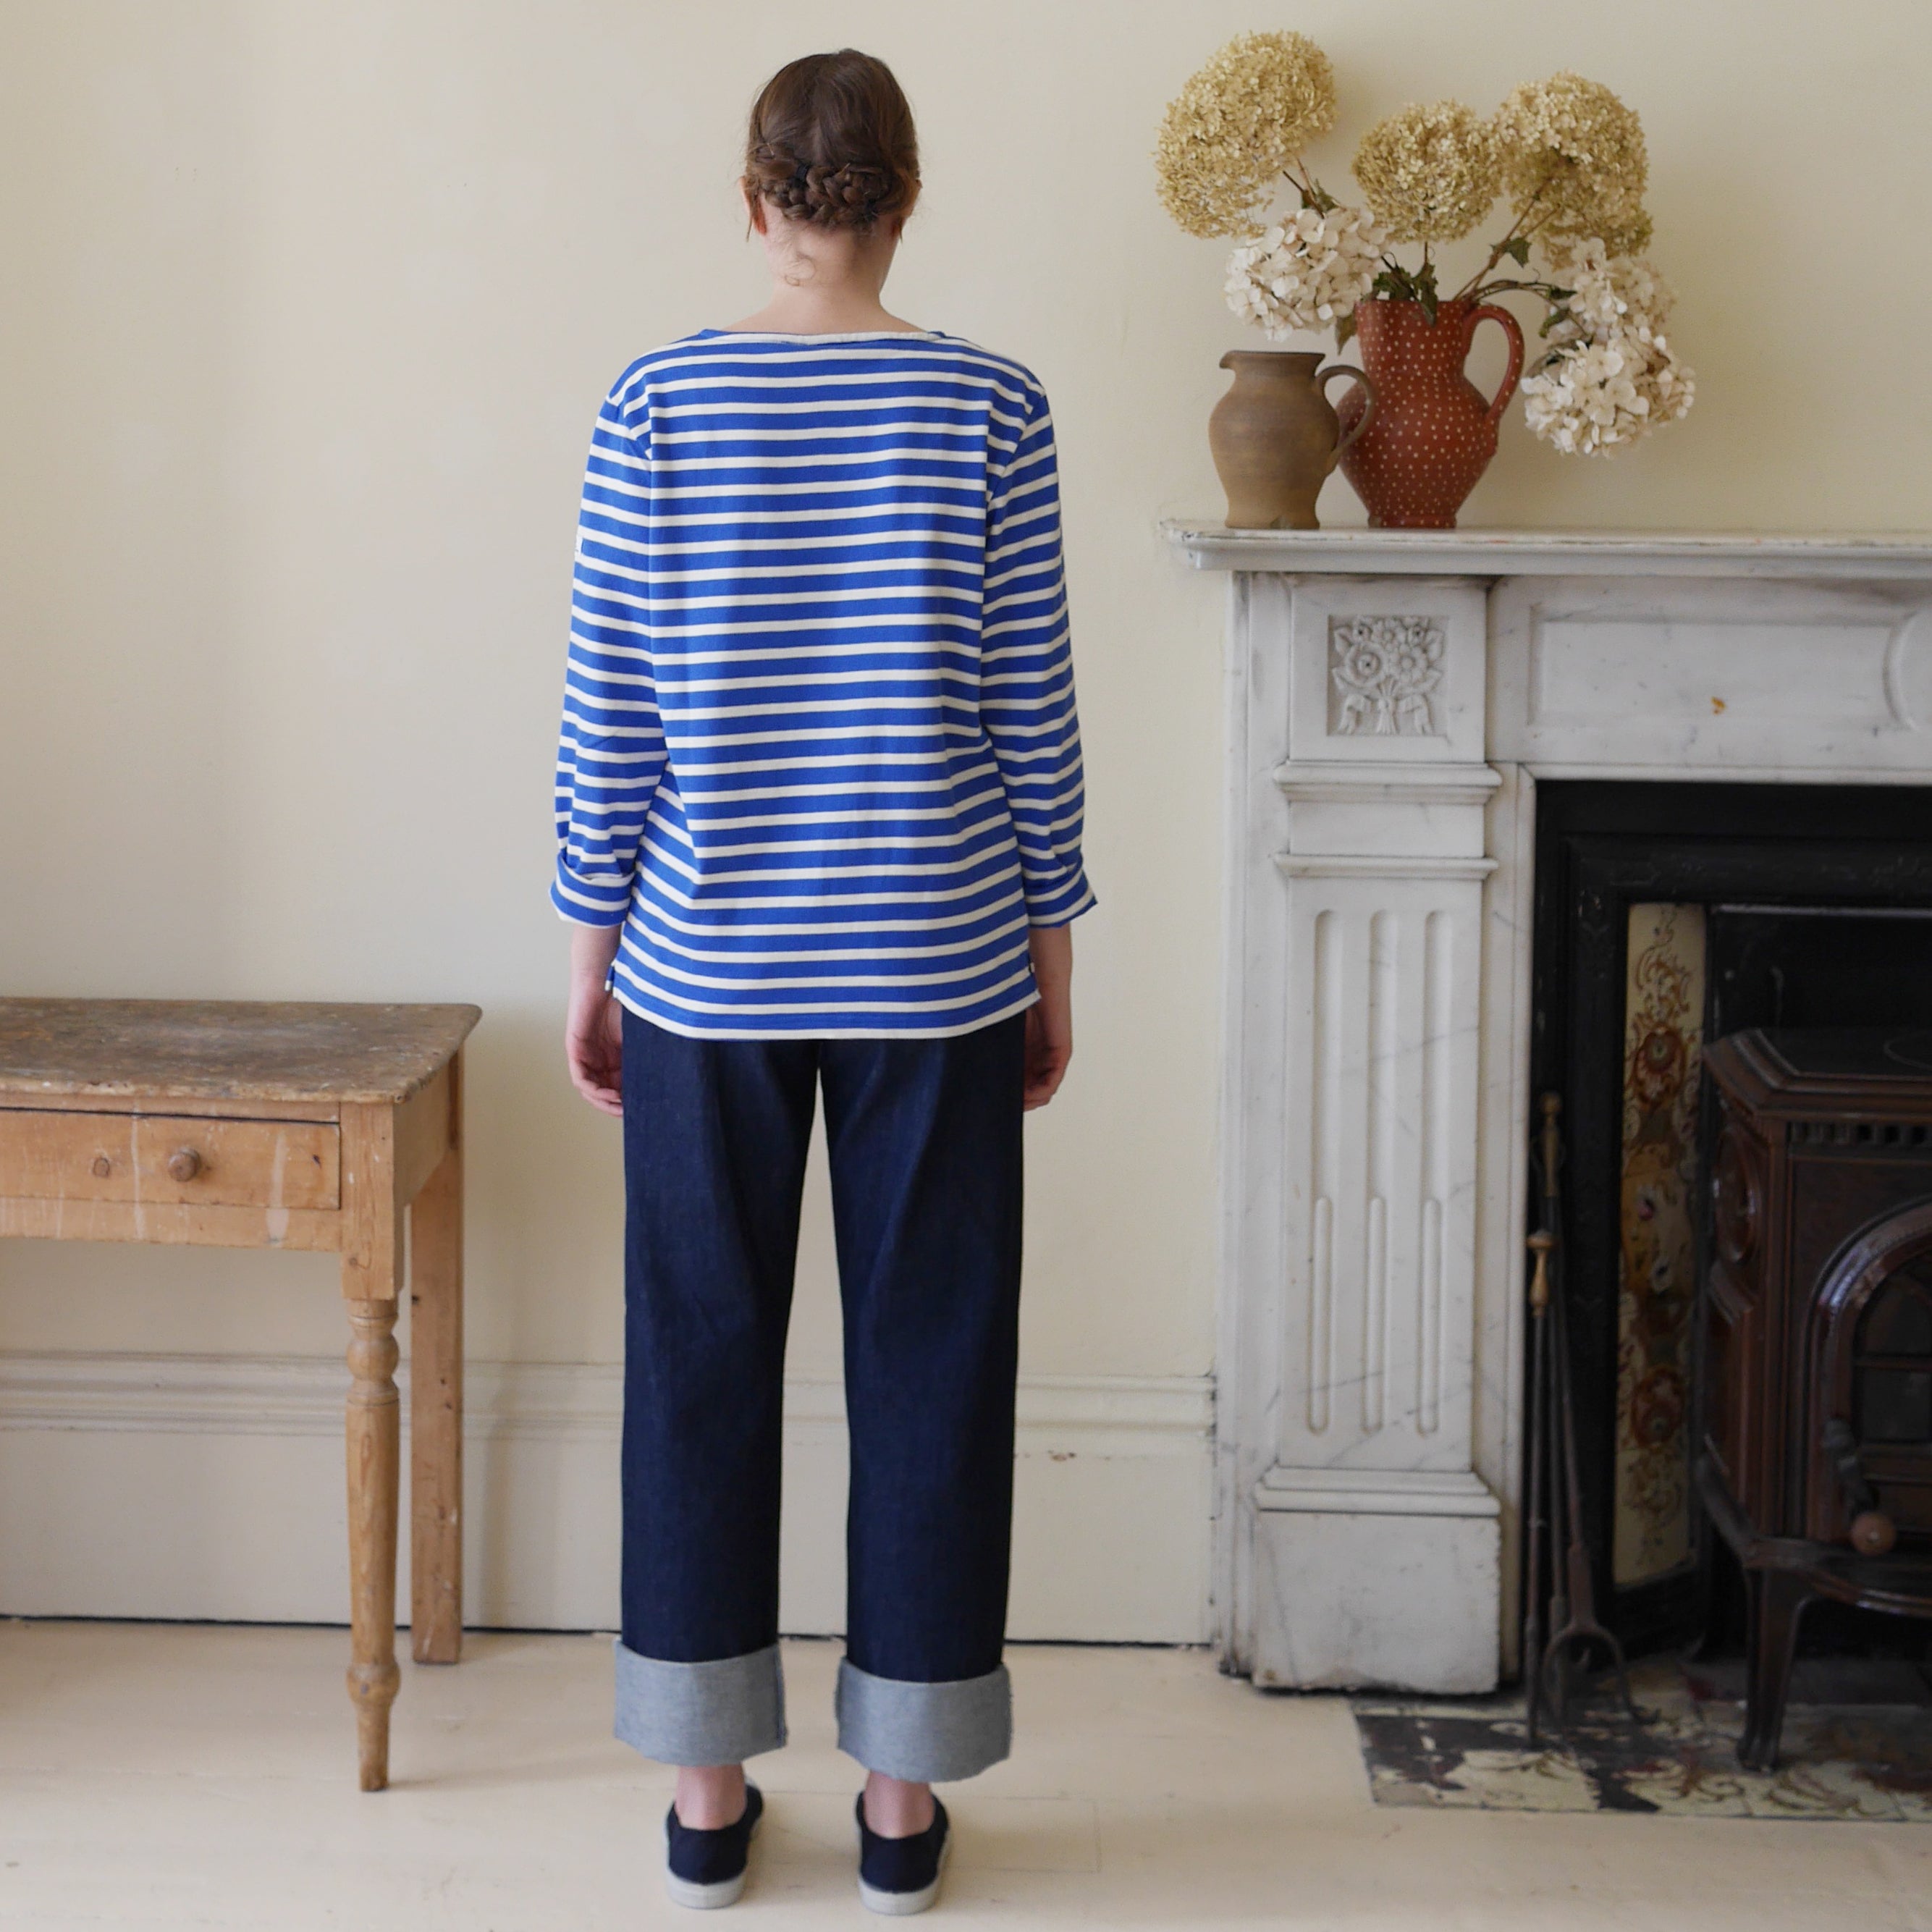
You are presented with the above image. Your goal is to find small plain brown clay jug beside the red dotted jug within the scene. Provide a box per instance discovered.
[1207,350,1375,529]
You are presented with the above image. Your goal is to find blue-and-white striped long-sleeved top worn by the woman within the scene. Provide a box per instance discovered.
[551,329,1094,1039]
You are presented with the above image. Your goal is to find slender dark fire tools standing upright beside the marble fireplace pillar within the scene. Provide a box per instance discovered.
[1522,1094,1642,1745]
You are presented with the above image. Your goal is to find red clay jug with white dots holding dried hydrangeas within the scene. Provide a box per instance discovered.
[1341,300,1522,529]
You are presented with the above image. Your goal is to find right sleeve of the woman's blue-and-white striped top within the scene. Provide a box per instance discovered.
[979,387,1094,925]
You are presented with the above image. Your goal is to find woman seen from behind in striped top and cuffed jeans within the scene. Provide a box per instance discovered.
[552,50,1094,1912]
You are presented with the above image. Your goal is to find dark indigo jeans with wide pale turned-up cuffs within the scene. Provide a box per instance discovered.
[616,1011,1026,1779]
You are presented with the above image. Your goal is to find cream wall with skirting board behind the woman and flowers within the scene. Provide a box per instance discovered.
[0,0,1932,1638]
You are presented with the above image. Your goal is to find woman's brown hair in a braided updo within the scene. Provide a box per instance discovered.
[744,46,919,228]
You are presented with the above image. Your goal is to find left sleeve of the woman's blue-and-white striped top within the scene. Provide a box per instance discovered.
[551,379,665,925]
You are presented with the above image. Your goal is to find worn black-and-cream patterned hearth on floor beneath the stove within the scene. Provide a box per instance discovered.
[1351,1658,1932,1824]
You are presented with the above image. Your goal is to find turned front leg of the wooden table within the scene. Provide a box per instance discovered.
[347,1299,402,1791]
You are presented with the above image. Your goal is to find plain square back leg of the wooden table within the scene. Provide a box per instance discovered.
[410,1121,464,1663]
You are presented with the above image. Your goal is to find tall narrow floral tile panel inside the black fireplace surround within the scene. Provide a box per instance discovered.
[1613,904,1704,1588]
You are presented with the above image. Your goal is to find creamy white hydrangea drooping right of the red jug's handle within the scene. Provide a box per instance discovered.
[1522,236,1696,456]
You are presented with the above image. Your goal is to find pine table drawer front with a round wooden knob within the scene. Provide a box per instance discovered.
[0,1107,342,1207]
